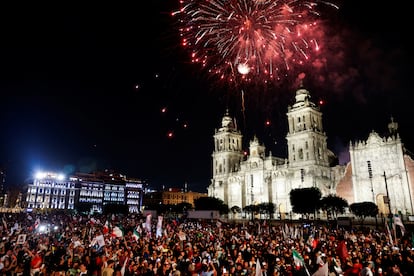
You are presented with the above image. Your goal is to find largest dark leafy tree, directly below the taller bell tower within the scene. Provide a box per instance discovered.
[289,187,322,219]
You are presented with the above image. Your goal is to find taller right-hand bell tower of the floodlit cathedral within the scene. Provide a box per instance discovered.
[286,88,329,168]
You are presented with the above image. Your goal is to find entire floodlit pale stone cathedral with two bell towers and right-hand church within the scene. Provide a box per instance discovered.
[208,88,414,217]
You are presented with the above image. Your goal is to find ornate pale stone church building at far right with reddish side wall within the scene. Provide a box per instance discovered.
[337,118,414,215]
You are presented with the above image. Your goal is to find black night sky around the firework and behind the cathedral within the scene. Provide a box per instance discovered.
[0,0,414,192]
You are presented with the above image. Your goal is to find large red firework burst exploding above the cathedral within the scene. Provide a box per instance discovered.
[173,0,338,86]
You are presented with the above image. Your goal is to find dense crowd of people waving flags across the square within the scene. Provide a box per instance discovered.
[0,210,414,276]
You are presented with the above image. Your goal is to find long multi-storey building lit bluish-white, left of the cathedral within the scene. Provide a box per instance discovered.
[26,171,143,213]
